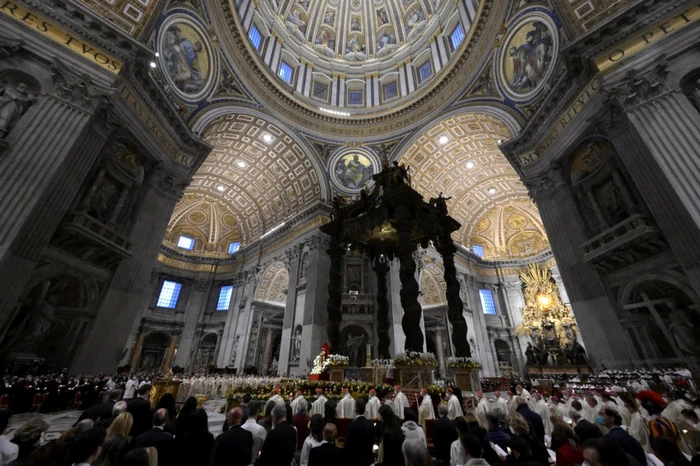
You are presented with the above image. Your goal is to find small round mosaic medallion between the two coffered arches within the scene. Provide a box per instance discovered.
[328,147,381,194]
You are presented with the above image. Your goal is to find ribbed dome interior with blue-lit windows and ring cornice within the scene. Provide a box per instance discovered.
[215,0,505,141]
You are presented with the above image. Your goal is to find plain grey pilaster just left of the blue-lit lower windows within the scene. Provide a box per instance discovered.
[71,170,183,374]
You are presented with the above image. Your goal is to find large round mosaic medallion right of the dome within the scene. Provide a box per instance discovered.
[496,9,559,102]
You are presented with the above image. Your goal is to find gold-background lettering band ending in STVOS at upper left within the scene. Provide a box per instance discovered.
[0,0,122,74]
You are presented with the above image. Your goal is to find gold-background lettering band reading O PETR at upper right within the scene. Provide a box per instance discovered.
[593,2,700,72]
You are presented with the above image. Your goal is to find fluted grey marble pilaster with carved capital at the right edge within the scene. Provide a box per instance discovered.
[608,92,700,294]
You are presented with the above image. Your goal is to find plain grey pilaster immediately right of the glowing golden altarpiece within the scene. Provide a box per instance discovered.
[526,167,637,367]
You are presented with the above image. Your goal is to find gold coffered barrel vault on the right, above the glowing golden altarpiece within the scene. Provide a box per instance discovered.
[401,112,548,259]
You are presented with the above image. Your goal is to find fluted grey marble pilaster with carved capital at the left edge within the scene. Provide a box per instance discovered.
[0,73,108,340]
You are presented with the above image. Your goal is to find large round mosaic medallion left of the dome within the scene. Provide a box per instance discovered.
[157,13,216,101]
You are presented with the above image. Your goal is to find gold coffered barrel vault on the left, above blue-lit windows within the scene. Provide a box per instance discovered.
[165,114,325,255]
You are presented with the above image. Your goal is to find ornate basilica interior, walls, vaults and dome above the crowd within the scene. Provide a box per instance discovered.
[0,0,700,377]
